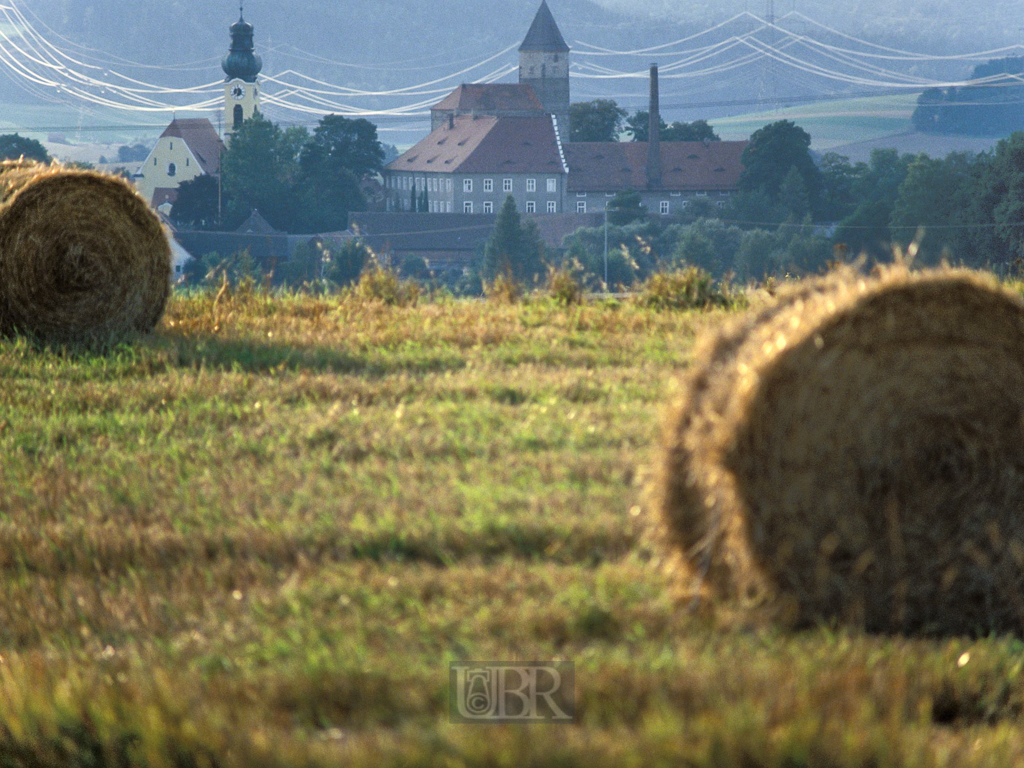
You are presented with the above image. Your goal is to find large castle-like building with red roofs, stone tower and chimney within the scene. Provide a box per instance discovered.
[384,6,746,221]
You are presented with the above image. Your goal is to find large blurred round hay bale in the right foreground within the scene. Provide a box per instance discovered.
[653,269,1024,634]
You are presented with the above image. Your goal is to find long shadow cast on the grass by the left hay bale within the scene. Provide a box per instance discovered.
[152,334,466,376]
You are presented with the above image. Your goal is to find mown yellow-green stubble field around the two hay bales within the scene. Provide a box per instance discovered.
[0,288,1024,768]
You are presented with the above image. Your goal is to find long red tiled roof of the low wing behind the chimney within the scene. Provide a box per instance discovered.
[565,141,748,193]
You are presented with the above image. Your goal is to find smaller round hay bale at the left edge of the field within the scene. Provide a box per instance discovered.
[0,163,171,345]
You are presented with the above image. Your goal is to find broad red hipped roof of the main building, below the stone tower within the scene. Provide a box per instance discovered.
[387,117,564,173]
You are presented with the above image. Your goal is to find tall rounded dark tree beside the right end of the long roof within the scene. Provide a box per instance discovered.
[739,120,823,215]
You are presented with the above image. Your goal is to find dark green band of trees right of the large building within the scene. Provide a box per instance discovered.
[552,121,1024,285]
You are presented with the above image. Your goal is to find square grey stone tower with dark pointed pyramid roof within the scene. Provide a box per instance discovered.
[519,0,569,141]
